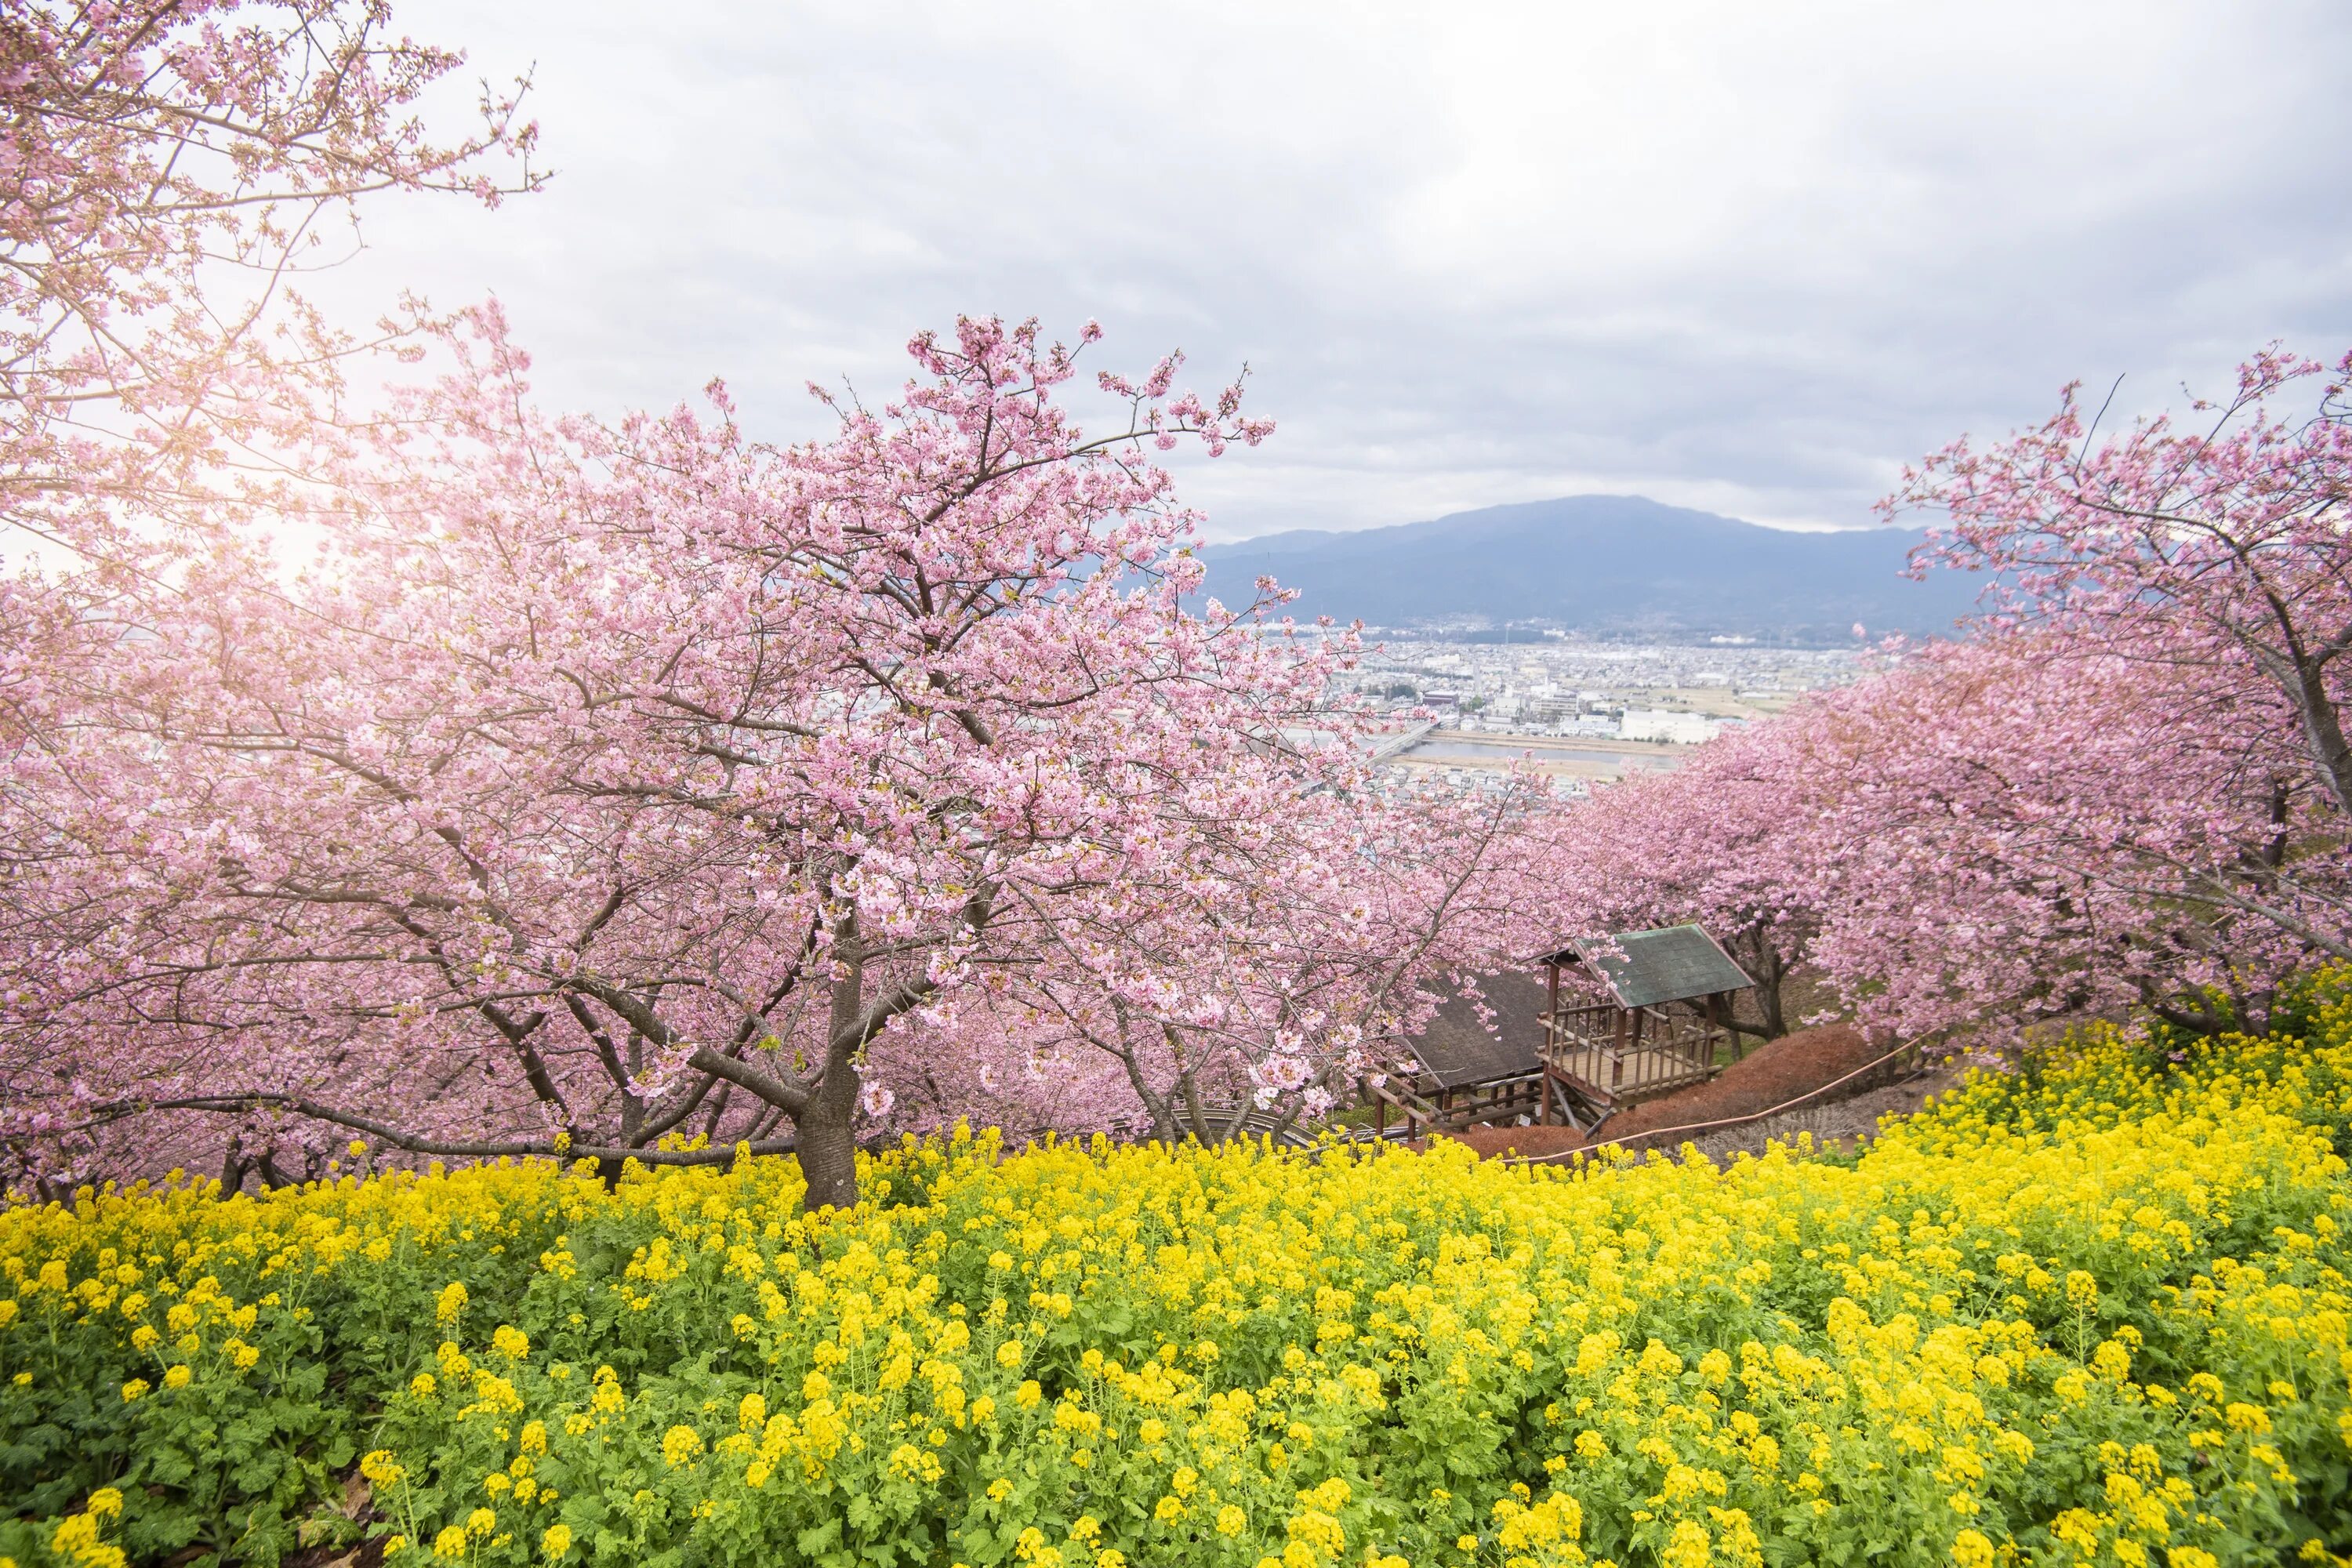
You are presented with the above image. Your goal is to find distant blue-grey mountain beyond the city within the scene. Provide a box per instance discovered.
[1202,496,1983,642]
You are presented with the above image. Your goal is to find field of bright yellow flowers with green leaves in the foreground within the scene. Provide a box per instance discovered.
[0,982,2352,1568]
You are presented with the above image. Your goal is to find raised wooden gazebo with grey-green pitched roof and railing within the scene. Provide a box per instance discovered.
[1538,926,1755,1126]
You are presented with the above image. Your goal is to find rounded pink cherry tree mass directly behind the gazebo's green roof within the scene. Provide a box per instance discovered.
[1505,630,2331,1034]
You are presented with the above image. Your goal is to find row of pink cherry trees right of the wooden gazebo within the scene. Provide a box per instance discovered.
[1543,353,2352,1048]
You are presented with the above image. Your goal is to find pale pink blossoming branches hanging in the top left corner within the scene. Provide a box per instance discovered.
[0,0,541,567]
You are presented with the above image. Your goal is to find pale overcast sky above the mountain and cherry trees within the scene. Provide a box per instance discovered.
[329,0,2352,536]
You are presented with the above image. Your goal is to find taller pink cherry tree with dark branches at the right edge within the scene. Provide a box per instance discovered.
[1835,348,2352,1027]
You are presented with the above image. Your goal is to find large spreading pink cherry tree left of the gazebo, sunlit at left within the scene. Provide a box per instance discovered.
[0,313,1505,1203]
